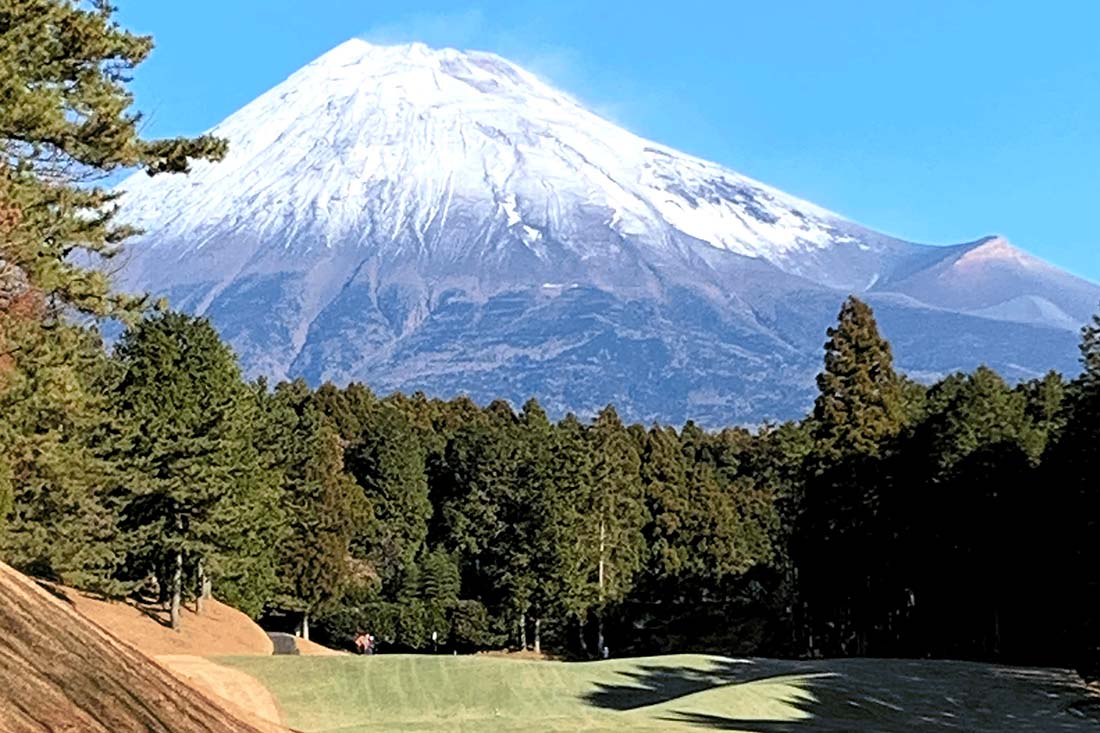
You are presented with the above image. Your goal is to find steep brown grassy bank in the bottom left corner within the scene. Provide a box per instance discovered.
[0,562,281,733]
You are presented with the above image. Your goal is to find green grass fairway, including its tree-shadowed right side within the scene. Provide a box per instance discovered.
[218,655,1100,733]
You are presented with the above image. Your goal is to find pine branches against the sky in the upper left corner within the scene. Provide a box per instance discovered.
[0,0,226,315]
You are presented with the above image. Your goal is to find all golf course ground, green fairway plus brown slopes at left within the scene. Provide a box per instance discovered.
[0,554,1100,733]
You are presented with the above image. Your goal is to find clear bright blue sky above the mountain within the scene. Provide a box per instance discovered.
[117,0,1100,281]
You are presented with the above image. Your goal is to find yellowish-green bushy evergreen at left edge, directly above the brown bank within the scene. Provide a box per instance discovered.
[0,320,124,594]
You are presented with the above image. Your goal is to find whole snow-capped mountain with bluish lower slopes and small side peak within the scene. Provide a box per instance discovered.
[113,41,1100,423]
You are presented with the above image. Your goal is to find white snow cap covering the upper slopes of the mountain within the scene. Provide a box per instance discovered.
[123,41,854,270]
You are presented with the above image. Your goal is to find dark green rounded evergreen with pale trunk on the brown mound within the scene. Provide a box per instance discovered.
[113,313,283,627]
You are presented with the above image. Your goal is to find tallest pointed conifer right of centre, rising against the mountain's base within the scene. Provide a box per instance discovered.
[795,297,906,654]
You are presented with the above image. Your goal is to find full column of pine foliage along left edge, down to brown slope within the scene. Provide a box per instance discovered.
[0,0,224,592]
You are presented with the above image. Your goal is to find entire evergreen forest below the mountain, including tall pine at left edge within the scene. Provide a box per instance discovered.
[0,0,1100,669]
